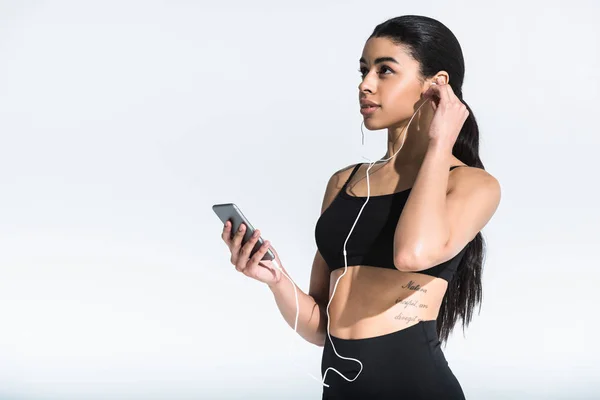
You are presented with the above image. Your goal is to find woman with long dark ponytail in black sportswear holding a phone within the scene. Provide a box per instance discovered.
[222,15,500,399]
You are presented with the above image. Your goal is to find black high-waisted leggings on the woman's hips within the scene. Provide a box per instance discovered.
[321,320,465,400]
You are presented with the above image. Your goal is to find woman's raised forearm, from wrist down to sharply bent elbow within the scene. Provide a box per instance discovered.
[394,142,452,268]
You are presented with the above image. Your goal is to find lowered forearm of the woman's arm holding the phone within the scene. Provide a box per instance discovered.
[269,267,327,346]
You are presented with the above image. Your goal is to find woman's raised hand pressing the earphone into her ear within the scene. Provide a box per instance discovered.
[424,84,469,149]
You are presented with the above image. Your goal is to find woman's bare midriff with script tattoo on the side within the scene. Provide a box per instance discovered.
[329,265,448,339]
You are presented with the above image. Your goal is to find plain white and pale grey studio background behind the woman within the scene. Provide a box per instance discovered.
[0,0,600,400]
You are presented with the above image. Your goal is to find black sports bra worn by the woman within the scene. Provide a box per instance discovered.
[315,164,466,282]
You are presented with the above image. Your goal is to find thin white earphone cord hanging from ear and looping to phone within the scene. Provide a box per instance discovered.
[271,94,435,387]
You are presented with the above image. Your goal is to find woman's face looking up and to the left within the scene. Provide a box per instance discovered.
[358,38,426,130]
